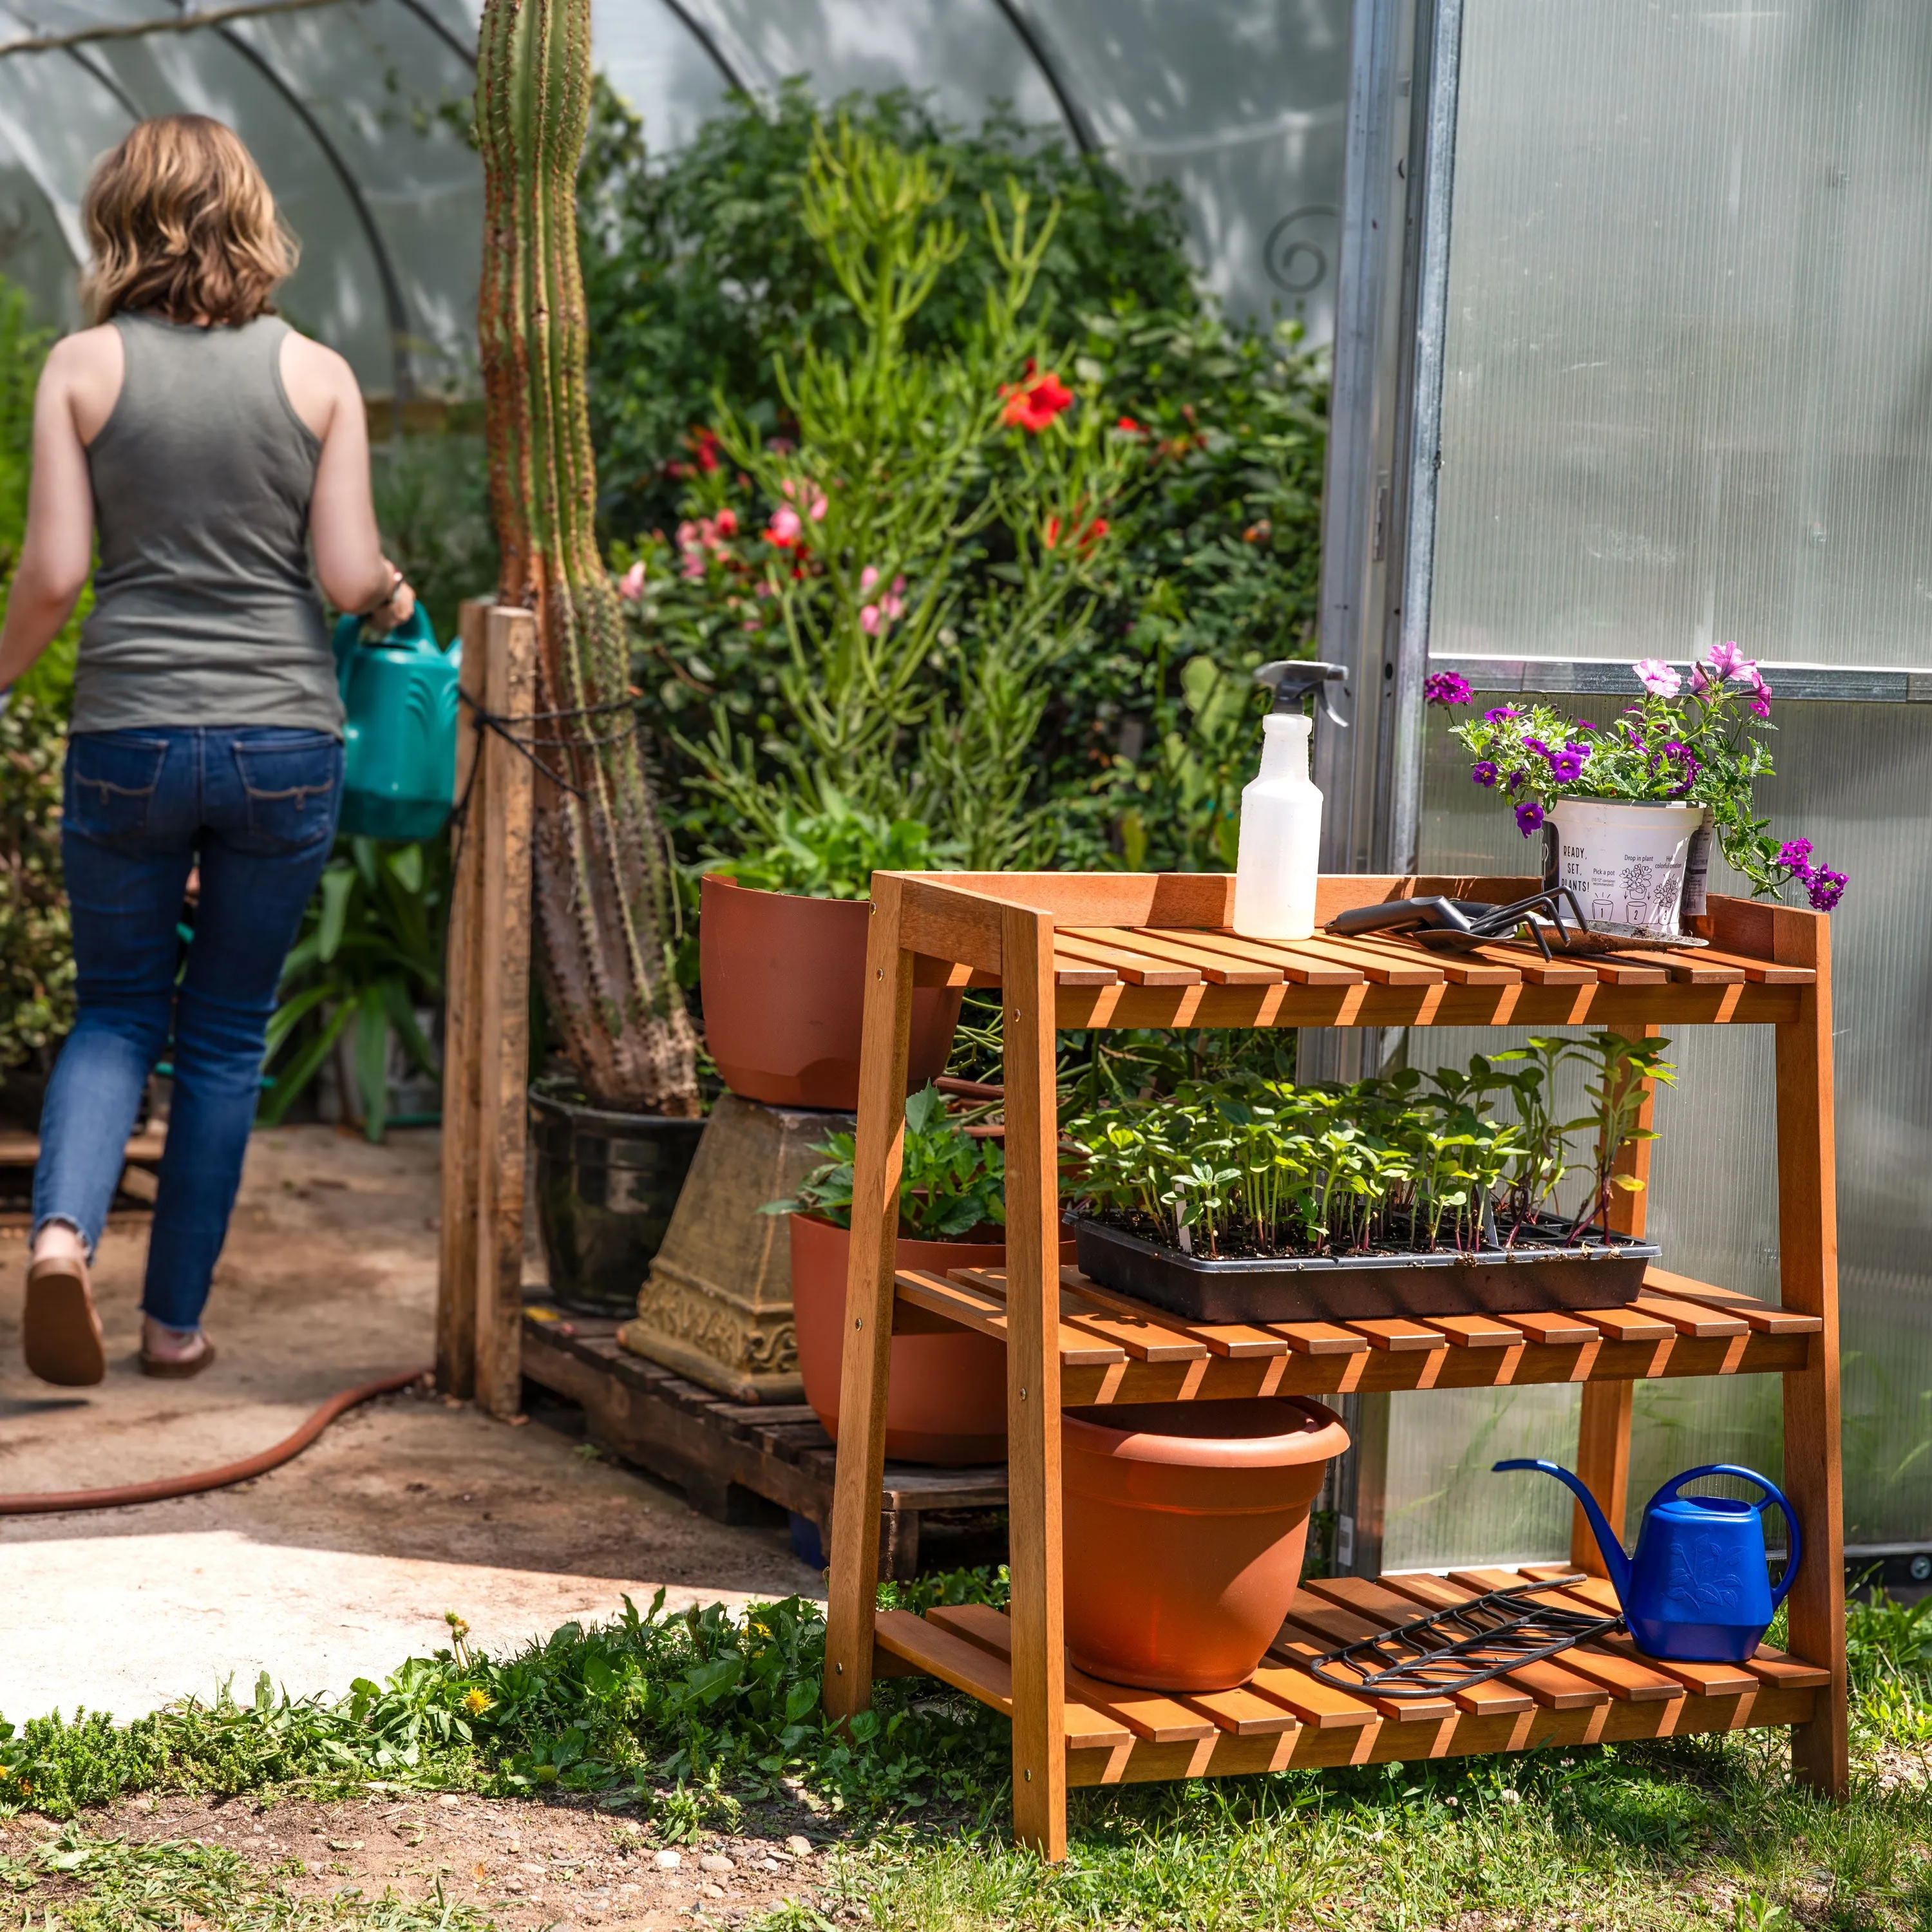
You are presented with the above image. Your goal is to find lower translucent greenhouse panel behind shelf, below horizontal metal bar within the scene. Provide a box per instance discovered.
[1385,699,1932,1567]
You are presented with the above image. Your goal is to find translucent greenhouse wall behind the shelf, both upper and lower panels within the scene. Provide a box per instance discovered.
[1385,0,1932,1565]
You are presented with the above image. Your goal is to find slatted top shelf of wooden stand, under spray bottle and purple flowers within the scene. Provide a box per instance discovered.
[896,873,1824,1028]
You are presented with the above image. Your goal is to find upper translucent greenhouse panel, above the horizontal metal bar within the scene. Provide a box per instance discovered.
[1432,0,1932,667]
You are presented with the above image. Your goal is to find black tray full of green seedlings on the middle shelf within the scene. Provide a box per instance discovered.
[1068,1034,1671,1321]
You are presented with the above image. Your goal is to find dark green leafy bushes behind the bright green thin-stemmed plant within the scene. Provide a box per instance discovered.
[580,89,1327,869]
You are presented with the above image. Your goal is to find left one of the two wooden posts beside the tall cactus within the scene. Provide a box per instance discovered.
[437,597,491,1399]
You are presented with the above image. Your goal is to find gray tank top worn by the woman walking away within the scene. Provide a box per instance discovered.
[73,315,342,736]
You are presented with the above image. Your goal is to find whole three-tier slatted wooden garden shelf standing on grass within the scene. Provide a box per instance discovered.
[825,873,1849,1857]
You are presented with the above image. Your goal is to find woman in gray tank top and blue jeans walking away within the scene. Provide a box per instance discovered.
[0,114,415,1387]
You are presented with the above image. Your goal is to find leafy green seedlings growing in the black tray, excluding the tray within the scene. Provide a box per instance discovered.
[1068,1034,1675,1260]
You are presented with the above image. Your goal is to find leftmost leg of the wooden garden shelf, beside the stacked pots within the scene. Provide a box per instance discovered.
[825,873,912,1721]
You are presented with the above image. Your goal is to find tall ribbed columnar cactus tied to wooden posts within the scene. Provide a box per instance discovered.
[477,0,697,1113]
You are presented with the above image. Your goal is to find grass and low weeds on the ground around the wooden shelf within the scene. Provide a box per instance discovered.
[0,1573,1932,1932]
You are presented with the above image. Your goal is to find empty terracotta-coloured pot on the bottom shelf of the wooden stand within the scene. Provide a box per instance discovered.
[1061,1395,1349,1690]
